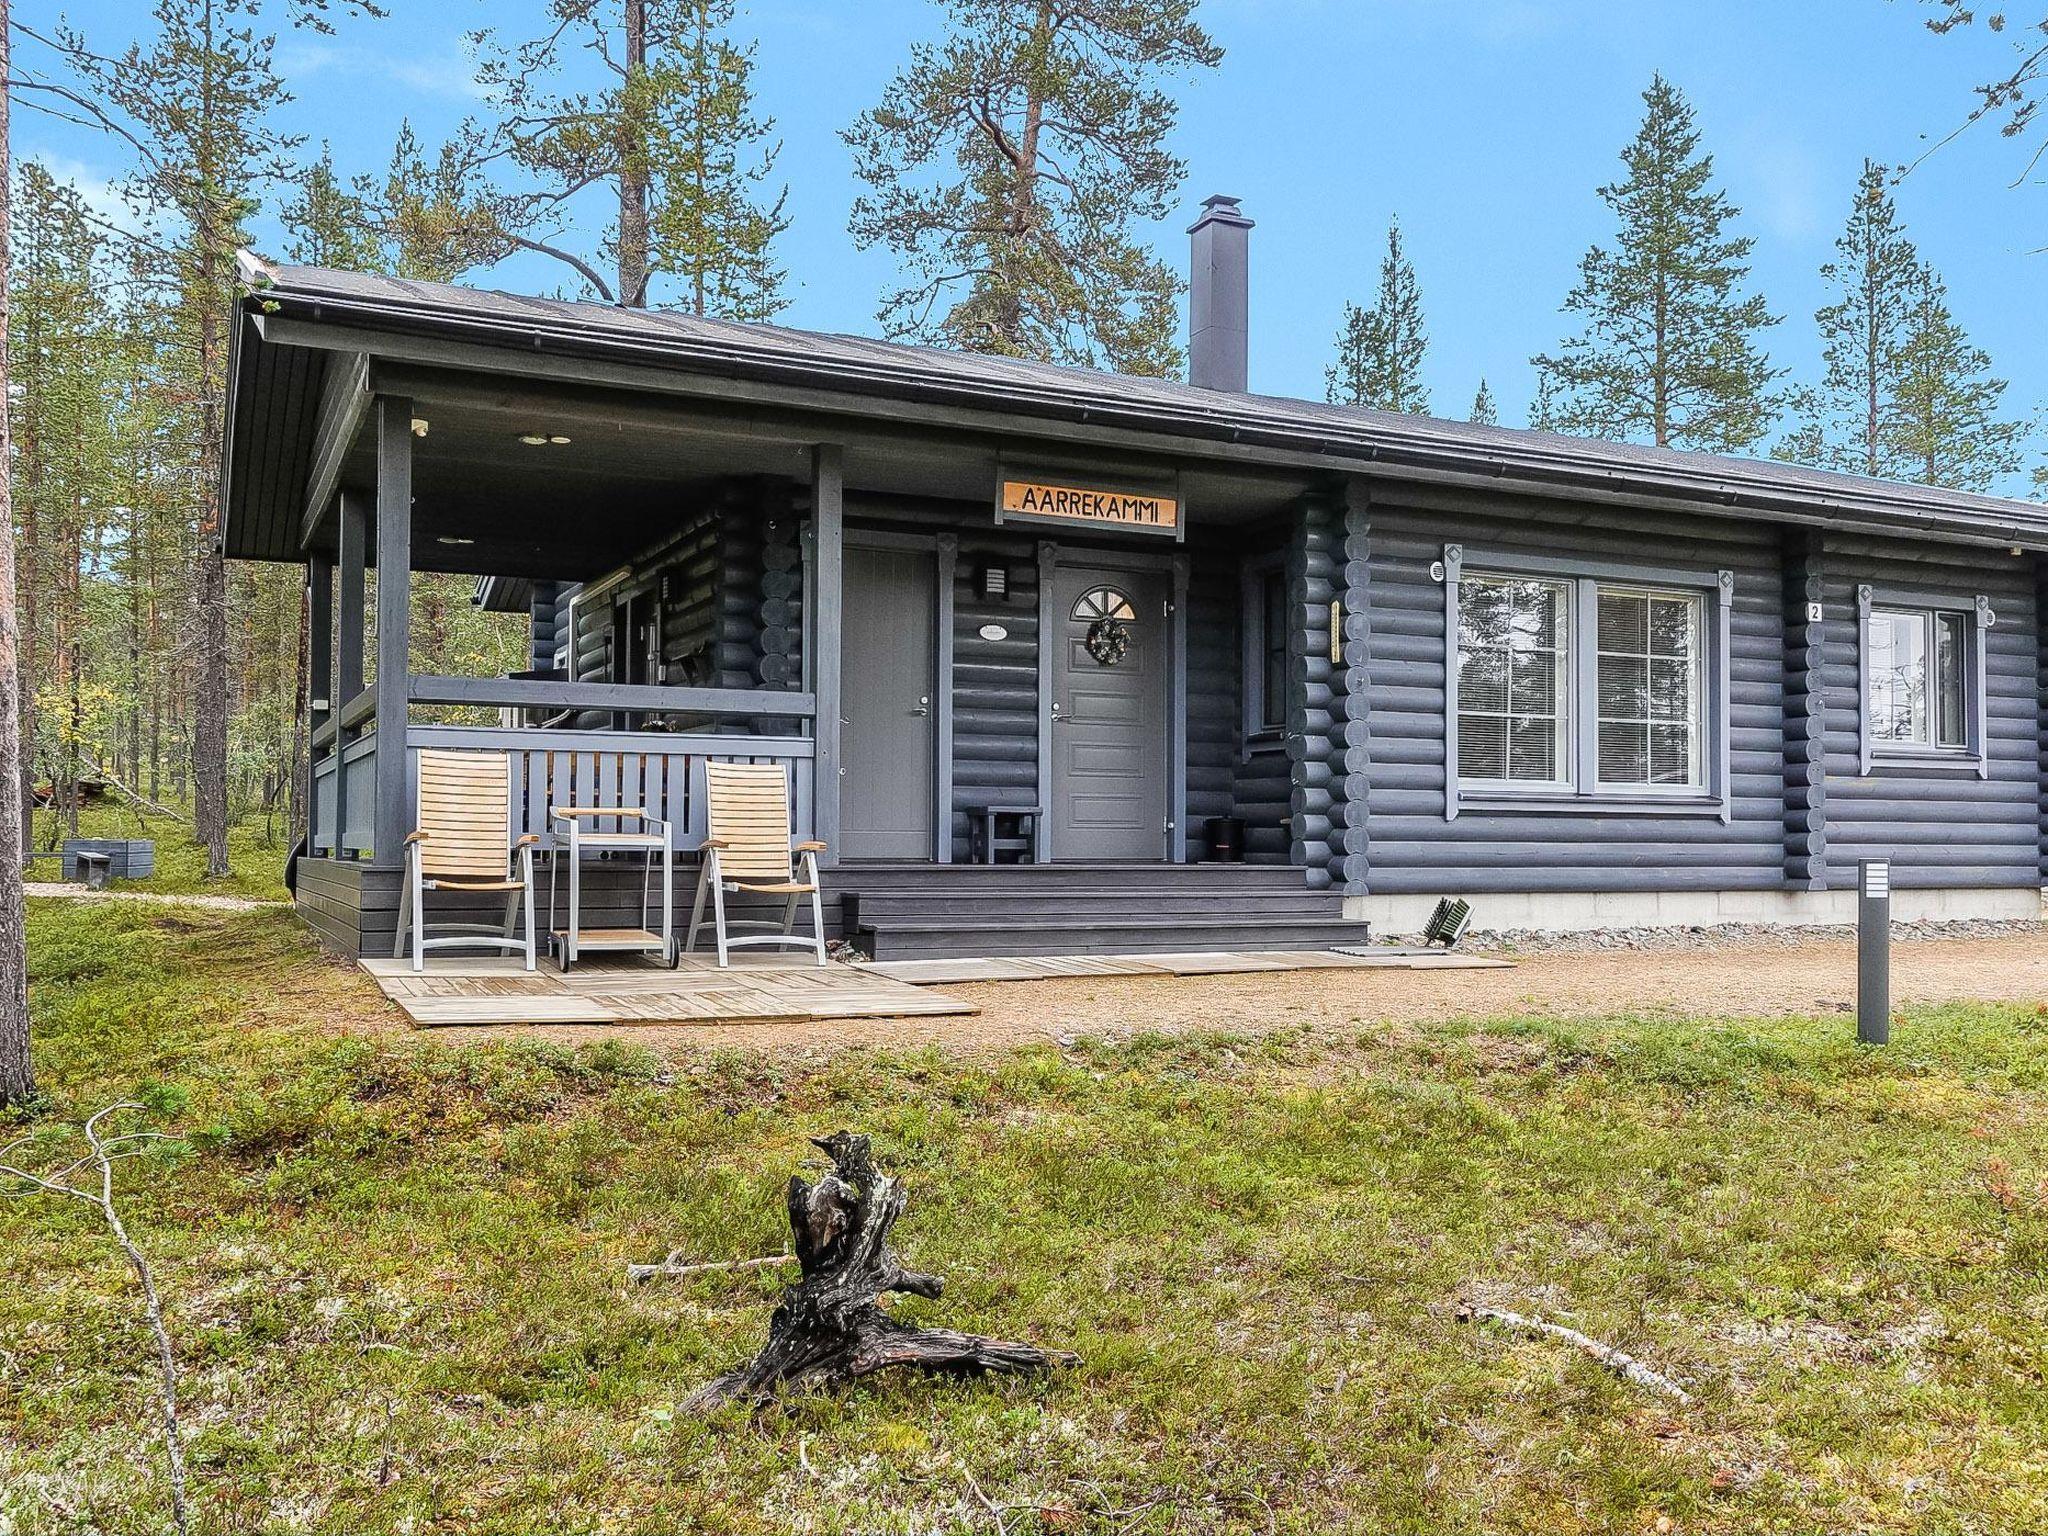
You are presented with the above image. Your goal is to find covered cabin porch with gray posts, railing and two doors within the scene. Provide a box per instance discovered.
[236,274,1362,958]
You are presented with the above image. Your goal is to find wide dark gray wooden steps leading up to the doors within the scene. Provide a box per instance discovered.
[825,864,1366,961]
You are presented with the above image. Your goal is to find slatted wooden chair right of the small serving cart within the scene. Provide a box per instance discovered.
[682,762,825,965]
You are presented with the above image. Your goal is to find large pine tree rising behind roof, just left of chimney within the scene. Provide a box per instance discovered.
[842,0,1223,375]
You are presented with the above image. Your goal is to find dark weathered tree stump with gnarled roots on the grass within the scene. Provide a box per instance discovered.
[684,1130,1077,1413]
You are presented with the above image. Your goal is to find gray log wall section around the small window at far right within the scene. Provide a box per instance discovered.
[1821,537,2042,891]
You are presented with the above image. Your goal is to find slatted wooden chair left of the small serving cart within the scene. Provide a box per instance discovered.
[391,752,541,971]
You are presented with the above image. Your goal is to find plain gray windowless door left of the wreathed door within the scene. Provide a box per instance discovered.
[840,545,938,858]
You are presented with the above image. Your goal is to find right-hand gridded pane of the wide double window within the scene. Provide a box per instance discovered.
[1595,588,1706,786]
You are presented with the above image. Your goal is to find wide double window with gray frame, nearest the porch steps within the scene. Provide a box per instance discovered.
[1432,545,1735,821]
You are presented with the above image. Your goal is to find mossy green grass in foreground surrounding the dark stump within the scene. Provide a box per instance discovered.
[0,884,2048,1536]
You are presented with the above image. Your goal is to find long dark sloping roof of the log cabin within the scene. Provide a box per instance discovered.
[229,260,2048,561]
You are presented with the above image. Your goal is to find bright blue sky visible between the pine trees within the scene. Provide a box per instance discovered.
[16,0,2048,493]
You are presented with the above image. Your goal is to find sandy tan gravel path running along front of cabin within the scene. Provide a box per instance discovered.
[380,930,2048,1055]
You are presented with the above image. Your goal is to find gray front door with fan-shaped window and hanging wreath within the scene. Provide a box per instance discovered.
[1049,565,1169,860]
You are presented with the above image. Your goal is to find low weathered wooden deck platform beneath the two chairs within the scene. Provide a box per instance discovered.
[360,954,979,1028]
